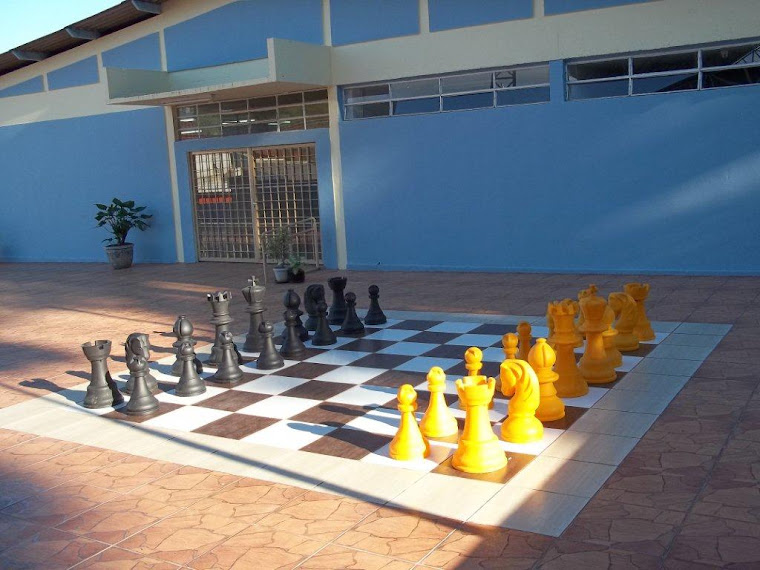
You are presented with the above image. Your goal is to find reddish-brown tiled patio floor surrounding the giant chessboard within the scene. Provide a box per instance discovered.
[0,264,760,569]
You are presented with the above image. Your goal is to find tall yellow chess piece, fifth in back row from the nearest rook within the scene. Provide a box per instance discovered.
[578,295,617,384]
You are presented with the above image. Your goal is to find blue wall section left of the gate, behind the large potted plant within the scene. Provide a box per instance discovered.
[0,109,176,262]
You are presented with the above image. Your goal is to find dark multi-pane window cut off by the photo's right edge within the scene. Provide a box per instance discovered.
[566,42,760,100]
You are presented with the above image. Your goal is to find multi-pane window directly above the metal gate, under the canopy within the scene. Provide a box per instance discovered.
[174,89,329,140]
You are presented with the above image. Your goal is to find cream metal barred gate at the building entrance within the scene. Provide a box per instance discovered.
[190,144,321,264]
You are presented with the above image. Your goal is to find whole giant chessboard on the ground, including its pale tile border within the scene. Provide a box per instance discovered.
[0,311,729,535]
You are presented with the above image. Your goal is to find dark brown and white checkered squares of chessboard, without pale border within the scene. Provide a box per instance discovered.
[103,319,666,483]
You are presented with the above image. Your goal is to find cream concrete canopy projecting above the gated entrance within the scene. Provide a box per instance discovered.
[106,38,331,105]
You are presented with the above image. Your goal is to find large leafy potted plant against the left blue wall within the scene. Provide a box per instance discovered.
[95,198,153,269]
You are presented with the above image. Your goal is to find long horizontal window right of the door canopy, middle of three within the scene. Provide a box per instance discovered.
[343,64,549,121]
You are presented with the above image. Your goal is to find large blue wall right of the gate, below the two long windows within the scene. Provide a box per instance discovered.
[341,81,760,274]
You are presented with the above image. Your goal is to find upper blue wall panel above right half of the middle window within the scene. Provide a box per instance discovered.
[428,0,533,32]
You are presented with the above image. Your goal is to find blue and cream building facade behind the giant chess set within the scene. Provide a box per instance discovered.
[0,0,760,274]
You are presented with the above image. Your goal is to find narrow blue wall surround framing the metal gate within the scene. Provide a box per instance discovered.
[174,129,337,268]
